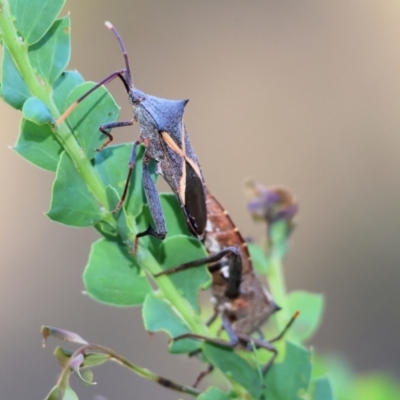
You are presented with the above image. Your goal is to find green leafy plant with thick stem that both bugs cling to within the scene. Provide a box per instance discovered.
[0,0,396,400]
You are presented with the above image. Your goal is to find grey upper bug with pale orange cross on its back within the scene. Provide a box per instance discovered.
[57,22,207,240]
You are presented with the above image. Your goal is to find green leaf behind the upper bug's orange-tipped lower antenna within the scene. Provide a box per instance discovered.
[67,82,119,159]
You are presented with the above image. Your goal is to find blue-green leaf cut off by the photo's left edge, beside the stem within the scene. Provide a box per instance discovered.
[1,43,30,110]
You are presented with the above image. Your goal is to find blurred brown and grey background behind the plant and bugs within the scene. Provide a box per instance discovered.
[0,0,400,400]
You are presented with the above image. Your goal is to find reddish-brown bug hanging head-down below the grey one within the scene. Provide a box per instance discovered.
[155,191,299,386]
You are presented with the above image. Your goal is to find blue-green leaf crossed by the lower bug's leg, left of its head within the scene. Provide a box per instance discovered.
[142,293,199,353]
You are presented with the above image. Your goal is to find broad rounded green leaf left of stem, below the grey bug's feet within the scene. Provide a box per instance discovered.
[83,239,152,307]
